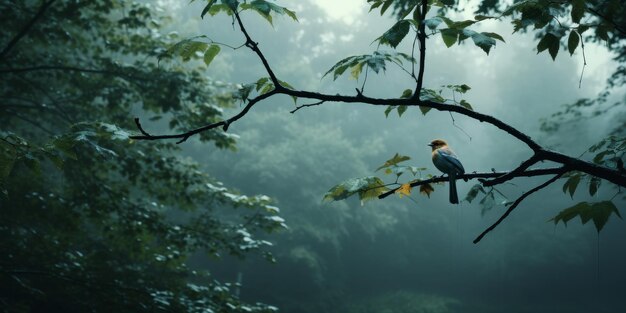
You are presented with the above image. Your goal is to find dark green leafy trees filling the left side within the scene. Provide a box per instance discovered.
[0,0,285,312]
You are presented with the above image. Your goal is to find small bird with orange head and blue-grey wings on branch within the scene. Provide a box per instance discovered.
[428,139,465,204]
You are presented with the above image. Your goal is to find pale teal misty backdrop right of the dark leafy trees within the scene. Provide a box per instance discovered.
[172,0,626,312]
